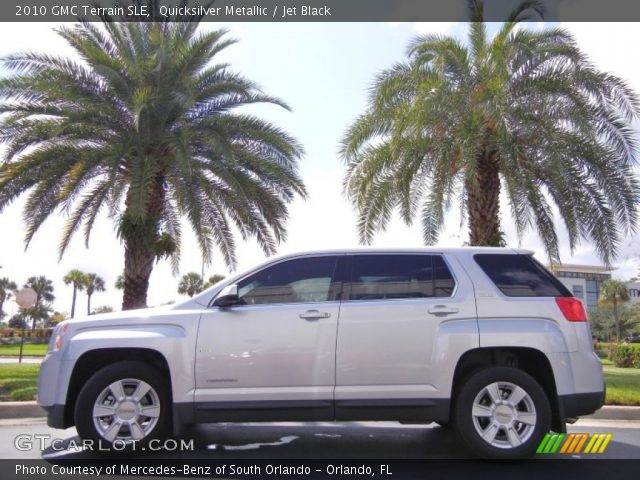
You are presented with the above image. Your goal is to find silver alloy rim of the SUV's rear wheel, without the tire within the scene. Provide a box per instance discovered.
[471,382,537,449]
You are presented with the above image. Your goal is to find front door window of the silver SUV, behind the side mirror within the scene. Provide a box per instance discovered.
[238,257,337,305]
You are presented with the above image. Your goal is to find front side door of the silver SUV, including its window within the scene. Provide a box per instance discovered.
[195,255,340,421]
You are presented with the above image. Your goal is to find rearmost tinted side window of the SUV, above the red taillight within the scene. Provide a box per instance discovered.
[474,253,571,297]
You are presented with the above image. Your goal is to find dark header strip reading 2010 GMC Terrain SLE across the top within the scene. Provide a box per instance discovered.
[0,0,640,23]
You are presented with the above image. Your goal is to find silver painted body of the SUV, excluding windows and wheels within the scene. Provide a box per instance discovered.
[38,248,604,428]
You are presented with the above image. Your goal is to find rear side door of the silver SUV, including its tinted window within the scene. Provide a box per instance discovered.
[335,253,478,420]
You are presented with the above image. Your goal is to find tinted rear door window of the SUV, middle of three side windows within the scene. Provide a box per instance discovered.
[349,255,455,300]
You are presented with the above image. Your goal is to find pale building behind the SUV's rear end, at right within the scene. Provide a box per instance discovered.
[551,263,616,310]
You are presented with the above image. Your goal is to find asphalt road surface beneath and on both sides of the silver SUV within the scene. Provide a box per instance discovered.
[0,419,640,460]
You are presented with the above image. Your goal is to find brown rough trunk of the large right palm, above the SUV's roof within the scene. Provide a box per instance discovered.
[466,150,502,246]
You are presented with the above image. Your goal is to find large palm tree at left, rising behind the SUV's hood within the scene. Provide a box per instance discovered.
[0,4,306,309]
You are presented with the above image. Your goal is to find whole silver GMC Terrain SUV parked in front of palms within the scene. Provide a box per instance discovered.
[38,248,604,458]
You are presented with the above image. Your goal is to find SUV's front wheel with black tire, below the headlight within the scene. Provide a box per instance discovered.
[74,361,171,454]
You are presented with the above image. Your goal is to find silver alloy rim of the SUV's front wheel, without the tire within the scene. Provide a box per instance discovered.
[93,378,160,443]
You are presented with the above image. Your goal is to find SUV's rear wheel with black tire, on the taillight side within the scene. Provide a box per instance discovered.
[452,367,551,459]
